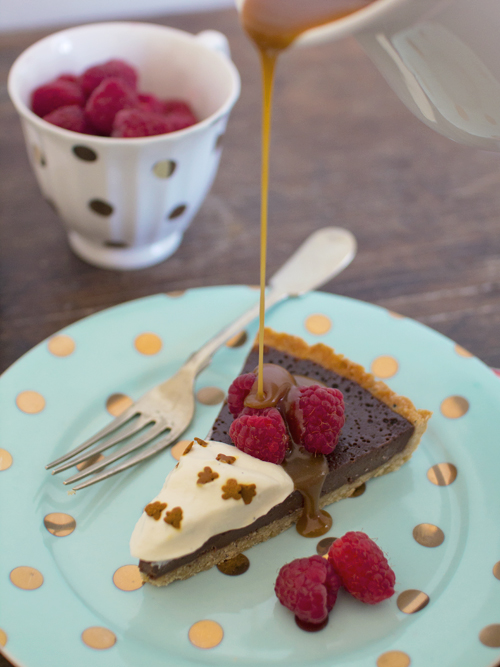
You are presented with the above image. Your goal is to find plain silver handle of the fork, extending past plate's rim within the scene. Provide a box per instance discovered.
[180,227,356,375]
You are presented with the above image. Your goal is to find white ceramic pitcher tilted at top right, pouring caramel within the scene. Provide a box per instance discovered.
[236,0,500,150]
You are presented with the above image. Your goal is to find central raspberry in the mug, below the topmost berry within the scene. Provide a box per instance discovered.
[85,78,138,136]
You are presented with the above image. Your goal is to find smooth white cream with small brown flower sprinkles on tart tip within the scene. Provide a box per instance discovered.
[130,440,294,561]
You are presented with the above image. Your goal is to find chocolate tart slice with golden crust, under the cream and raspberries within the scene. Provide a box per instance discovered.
[134,329,431,586]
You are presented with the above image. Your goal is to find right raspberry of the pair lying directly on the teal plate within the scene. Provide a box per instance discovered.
[328,531,396,604]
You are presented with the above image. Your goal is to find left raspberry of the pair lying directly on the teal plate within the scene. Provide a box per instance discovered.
[274,556,341,624]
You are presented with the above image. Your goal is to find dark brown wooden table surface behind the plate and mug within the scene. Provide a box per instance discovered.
[0,10,500,667]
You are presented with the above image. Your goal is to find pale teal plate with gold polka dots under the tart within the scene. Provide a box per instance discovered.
[0,286,500,667]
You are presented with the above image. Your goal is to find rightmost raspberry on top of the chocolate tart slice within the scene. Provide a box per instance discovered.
[288,384,345,454]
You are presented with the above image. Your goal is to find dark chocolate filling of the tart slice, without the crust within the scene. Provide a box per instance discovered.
[139,348,414,579]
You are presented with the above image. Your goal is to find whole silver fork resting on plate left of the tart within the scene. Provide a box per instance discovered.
[46,227,356,491]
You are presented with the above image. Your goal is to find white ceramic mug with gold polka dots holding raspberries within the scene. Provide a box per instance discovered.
[8,22,240,270]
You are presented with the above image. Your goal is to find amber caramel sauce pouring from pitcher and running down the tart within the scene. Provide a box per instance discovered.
[241,0,374,537]
